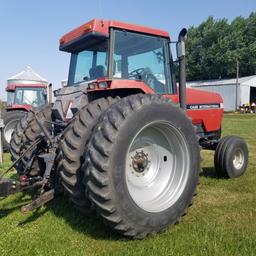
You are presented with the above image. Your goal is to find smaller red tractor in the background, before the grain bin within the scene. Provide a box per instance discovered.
[2,70,51,150]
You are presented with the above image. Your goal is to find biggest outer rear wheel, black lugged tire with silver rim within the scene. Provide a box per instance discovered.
[83,94,200,238]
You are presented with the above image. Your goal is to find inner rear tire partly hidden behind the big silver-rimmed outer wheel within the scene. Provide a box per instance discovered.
[56,97,117,212]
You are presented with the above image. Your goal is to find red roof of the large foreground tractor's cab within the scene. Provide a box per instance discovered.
[60,19,169,50]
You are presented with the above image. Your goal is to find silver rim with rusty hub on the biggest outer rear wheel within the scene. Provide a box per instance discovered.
[125,121,190,213]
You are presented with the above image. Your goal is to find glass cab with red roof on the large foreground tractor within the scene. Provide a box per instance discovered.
[60,20,176,94]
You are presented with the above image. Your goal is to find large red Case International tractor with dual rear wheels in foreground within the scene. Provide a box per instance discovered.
[0,20,248,238]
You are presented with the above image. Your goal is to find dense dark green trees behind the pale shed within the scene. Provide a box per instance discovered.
[186,12,256,81]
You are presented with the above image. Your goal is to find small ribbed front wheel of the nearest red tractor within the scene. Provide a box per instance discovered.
[214,136,249,178]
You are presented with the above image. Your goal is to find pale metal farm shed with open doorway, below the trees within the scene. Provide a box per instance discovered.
[187,75,256,111]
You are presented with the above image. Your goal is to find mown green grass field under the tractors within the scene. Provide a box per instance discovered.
[0,114,256,256]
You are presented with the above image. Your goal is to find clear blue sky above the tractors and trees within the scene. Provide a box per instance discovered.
[0,0,256,99]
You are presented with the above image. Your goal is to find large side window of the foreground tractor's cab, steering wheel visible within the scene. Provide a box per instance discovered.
[112,30,172,94]
